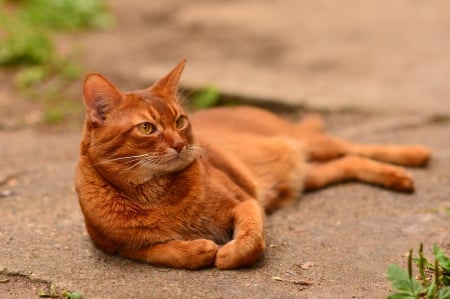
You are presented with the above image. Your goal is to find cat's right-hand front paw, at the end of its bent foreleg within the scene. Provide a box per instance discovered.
[214,239,265,270]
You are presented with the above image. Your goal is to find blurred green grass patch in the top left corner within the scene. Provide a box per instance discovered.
[0,0,113,124]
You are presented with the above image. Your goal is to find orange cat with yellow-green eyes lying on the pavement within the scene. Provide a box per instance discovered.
[75,60,431,269]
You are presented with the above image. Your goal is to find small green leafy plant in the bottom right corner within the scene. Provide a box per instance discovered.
[387,244,450,299]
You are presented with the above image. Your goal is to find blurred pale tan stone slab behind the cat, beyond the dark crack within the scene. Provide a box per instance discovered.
[81,0,450,114]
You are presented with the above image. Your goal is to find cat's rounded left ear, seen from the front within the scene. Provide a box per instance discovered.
[83,73,122,124]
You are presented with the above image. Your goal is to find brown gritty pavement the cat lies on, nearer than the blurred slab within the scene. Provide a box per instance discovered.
[0,113,450,298]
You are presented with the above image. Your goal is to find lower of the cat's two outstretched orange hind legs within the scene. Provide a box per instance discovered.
[305,155,414,192]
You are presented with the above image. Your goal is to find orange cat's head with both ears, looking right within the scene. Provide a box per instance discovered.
[82,60,199,184]
